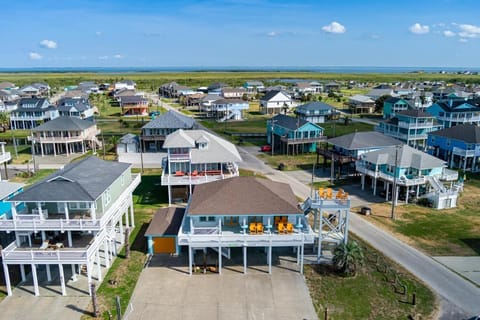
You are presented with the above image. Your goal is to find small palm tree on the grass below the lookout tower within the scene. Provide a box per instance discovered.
[333,240,364,276]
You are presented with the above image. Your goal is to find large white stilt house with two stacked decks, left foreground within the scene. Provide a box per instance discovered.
[0,157,140,295]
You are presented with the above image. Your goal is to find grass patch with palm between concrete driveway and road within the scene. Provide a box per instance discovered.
[305,235,436,320]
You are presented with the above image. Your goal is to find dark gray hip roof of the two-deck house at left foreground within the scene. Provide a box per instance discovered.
[10,156,131,202]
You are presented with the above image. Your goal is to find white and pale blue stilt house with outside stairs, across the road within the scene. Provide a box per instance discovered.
[356,144,458,209]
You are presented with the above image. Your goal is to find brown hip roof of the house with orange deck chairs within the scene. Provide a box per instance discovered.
[187,177,300,215]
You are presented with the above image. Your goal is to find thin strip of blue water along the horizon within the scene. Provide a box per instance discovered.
[0,66,480,74]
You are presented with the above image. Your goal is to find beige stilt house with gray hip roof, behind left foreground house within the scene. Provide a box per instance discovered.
[29,117,101,157]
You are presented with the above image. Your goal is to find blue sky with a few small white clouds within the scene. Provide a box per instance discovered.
[0,0,480,68]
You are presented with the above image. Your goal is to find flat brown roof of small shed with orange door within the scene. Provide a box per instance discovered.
[145,207,185,236]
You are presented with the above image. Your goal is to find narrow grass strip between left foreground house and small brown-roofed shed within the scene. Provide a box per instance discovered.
[83,169,168,319]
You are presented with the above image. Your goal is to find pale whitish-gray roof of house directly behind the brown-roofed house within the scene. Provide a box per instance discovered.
[163,129,242,163]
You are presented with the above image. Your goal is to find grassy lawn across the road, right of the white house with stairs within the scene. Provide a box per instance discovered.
[366,180,480,256]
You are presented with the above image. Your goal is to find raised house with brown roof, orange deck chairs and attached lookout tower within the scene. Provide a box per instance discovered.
[171,177,350,274]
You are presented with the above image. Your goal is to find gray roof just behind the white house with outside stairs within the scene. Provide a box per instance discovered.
[327,131,403,150]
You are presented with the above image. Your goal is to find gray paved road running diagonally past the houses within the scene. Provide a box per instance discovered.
[137,97,480,319]
